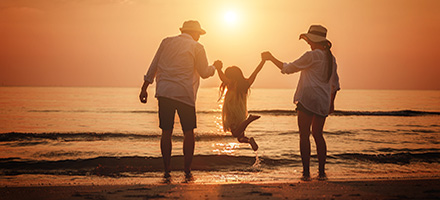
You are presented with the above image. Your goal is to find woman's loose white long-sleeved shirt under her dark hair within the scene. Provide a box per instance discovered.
[281,49,340,116]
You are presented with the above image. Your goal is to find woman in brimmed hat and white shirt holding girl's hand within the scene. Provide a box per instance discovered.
[262,25,340,180]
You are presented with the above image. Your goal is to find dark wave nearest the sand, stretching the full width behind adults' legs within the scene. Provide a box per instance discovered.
[0,151,440,176]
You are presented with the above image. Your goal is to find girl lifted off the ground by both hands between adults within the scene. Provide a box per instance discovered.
[215,57,265,151]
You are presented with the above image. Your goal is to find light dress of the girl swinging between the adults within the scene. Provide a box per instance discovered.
[222,88,248,134]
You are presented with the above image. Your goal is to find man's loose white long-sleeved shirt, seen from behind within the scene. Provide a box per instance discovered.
[144,33,215,107]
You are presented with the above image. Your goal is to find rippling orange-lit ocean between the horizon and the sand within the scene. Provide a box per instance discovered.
[0,87,440,186]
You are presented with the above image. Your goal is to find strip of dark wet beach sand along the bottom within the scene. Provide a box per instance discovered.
[0,179,440,200]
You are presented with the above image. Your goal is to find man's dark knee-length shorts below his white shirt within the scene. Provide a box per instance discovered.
[157,97,197,131]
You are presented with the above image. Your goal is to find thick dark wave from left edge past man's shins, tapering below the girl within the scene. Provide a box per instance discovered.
[0,155,285,176]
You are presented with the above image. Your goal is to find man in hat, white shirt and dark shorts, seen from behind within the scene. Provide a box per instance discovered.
[139,21,220,177]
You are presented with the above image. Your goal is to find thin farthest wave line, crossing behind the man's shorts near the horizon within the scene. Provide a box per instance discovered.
[28,109,440,117]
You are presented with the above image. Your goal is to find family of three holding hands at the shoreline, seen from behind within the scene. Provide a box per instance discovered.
[139,20,340,180]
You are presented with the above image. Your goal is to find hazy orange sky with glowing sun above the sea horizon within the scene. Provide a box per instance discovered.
[0,0,440,90]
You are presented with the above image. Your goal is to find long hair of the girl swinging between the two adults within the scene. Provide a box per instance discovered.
[219,66,249,100]
